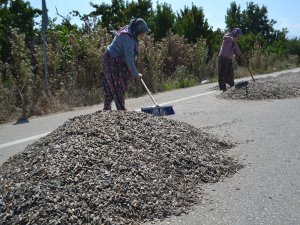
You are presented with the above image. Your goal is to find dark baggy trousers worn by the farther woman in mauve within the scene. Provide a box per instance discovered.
[218,56,234,91]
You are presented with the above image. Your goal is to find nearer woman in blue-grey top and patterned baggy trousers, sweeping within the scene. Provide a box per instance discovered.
[103,18,149,110]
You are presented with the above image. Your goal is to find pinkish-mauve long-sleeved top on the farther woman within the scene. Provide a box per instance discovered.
[219,33,241,59]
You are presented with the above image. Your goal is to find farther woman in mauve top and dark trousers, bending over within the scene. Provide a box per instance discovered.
[218,28,243,91]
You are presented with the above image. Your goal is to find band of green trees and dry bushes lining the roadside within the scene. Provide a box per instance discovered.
[0,0,300,123]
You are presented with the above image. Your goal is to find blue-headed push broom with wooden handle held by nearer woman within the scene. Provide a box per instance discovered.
[141,79,175,116]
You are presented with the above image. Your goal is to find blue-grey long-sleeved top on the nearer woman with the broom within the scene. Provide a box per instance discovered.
[107,33,139,76]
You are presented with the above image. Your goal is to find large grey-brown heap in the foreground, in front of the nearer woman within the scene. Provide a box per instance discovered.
[0,111,242,225]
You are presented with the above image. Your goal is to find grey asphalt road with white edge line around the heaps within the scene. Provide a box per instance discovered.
[0,69,300,225]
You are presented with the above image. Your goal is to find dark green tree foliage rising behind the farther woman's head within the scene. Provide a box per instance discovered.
[225,2,288,57]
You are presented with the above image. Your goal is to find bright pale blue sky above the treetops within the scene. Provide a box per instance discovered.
[26,0,300,38]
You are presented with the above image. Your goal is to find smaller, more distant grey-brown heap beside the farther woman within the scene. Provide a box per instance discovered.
[219,73,300,100]
